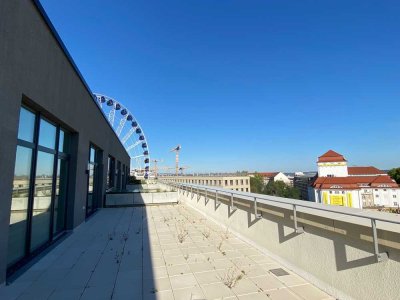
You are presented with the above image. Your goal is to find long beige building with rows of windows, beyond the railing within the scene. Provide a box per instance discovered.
[160,175,250,192]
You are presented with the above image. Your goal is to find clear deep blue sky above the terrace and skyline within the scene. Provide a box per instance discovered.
[41,0,400,171]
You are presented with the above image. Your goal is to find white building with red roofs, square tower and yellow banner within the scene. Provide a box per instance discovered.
[309,150,400,208]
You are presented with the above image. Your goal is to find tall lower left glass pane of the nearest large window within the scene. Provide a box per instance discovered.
[7,146,32,265]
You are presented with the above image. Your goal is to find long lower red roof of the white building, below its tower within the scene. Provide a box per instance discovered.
[312,175,399,190]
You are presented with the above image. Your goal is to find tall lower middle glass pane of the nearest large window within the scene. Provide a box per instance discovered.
[31,151,54,251]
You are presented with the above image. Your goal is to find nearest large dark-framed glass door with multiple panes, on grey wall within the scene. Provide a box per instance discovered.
[7,107,69,271]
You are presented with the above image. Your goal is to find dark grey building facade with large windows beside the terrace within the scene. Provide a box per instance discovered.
[0,0,130,284]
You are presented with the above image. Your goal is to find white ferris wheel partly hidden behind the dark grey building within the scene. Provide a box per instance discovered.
[93,93,150,179]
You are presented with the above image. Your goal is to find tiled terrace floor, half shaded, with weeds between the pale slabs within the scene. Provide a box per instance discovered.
[0,205,332,300]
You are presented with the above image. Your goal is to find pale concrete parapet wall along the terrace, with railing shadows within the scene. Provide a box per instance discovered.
[179,188,400,300]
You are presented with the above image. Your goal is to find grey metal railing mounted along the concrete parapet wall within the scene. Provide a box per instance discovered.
[160,180,400,262]
